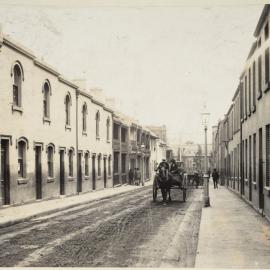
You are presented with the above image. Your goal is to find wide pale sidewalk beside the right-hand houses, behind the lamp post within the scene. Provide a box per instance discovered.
[195,181,270,268]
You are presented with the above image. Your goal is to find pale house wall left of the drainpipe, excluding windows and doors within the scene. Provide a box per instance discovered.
[0,38,76,204]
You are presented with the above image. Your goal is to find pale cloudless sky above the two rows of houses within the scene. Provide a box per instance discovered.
[0,0,263,144]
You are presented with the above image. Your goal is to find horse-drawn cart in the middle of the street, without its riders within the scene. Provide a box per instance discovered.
[153,174,187,202]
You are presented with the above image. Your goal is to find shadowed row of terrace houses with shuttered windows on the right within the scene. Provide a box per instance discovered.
[215,5,270,221]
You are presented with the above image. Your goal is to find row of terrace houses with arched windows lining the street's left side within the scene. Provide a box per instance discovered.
[0,32,169,206]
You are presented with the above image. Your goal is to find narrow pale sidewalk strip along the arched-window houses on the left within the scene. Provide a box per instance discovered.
[0,180,152,228]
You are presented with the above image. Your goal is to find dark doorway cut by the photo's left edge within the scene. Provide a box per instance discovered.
[0,139,10,205]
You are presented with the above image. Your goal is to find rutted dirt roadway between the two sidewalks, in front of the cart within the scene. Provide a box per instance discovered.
[0,187,202,267]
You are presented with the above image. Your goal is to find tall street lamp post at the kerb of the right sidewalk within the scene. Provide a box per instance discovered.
[201,112,210,207]
